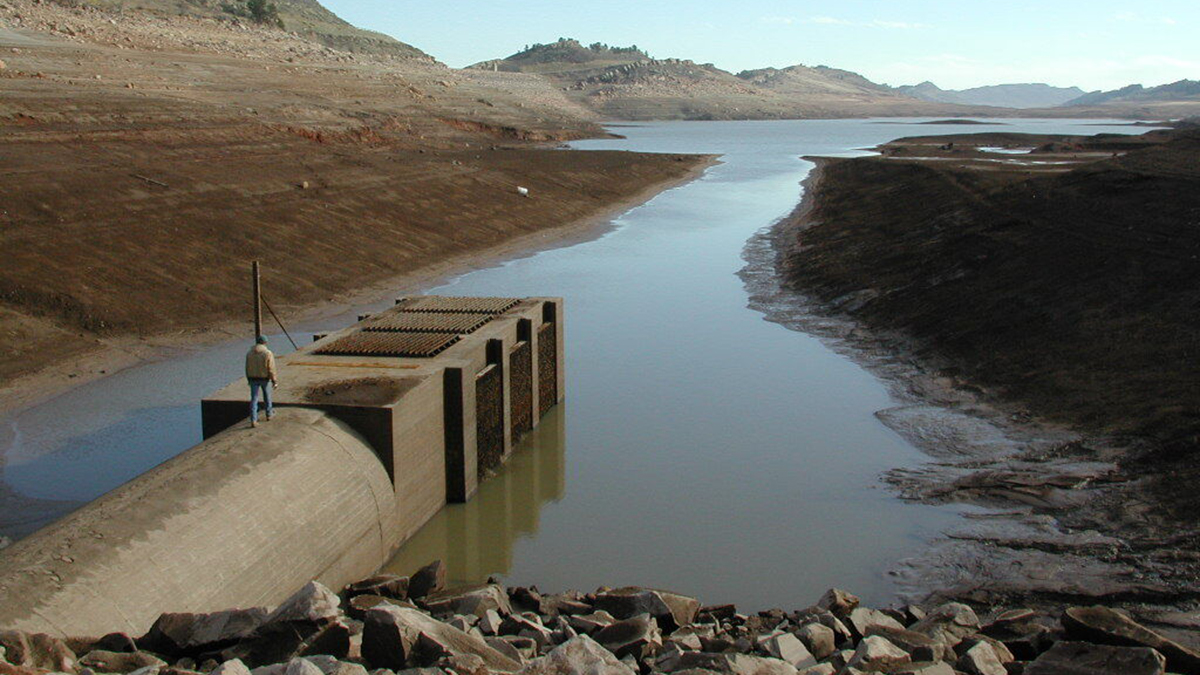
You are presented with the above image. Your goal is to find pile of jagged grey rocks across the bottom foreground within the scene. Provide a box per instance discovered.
[0,562,1200,675]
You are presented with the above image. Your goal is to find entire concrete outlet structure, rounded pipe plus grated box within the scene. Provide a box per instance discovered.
[0,295,565,635]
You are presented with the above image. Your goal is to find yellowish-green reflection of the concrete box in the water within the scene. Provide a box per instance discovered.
[384,402,566,584]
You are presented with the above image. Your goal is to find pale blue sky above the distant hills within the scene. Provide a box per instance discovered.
[323,0,1200,90]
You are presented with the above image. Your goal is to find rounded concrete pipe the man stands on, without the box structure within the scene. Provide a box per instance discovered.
[0,408,398,635]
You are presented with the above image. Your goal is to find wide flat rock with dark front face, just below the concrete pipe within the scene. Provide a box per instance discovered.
[141,607,268,657]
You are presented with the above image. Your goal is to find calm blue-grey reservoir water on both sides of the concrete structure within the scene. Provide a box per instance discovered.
[0,120,1161,609]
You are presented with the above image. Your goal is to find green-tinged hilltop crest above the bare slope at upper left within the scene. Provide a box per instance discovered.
[44,0,432,60]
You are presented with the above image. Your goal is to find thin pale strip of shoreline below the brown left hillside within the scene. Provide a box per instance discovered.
[0,150,720,422]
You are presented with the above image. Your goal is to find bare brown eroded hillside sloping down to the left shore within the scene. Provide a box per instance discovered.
[0,10,709,408]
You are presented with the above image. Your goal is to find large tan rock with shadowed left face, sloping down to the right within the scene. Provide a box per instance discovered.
[362,605,521,673]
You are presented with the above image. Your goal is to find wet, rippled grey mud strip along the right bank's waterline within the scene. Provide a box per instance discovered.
[739,159,1200,637]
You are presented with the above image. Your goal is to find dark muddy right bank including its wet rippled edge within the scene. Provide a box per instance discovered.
[744,128,1200,627]
